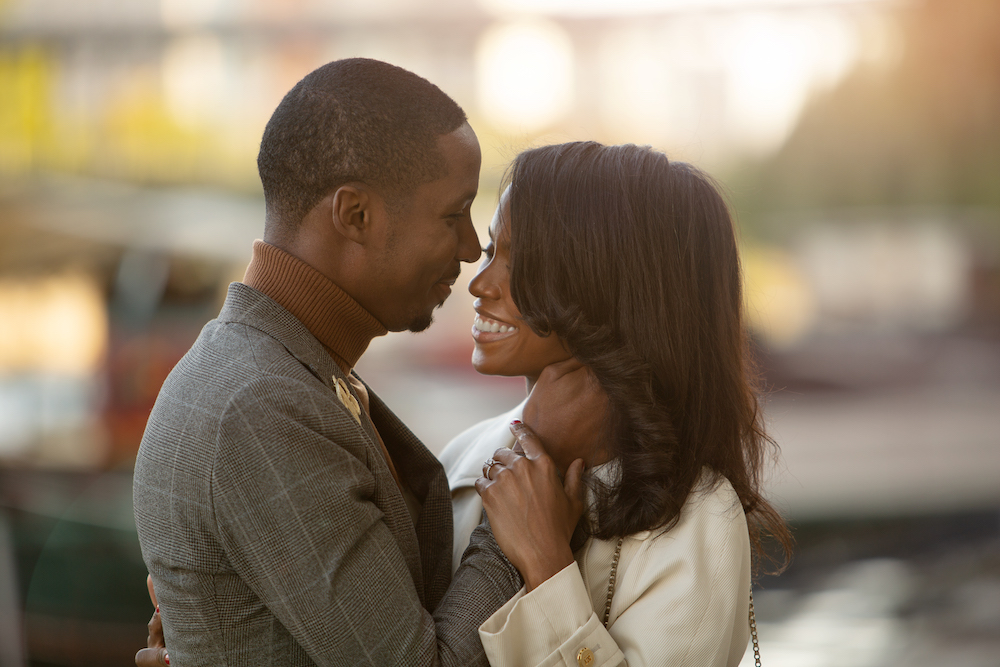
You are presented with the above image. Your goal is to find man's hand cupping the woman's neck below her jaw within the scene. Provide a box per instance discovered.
[522,359,610,472]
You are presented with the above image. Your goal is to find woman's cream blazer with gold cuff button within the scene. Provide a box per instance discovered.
[440,403,750,667]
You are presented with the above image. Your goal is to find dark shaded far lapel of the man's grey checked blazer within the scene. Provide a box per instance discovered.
[366,385,453,611]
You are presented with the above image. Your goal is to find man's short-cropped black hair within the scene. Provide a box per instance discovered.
[257,58,466,229]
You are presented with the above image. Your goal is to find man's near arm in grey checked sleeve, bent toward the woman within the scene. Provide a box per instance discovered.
[209,378,521,665]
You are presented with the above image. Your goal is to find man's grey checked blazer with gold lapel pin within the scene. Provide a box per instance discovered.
[133,283,521,667]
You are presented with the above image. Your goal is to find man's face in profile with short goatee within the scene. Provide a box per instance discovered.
[362,123,482,331]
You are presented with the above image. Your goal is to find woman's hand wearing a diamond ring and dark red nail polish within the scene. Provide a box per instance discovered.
[476,421,583,591]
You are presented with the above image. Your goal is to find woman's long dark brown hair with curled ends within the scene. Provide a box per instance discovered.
[507,142,791,566]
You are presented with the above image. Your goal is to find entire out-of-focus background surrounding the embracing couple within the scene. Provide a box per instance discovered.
[0,0,1000,667]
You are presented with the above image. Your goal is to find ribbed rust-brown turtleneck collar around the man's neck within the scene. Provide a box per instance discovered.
[243,240,388,373]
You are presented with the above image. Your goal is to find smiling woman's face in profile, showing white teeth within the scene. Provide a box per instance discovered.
[469,193,570,386]
